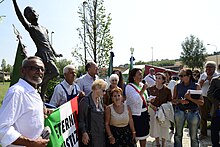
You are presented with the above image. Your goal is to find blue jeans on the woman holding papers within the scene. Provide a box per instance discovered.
[174,108,201,147]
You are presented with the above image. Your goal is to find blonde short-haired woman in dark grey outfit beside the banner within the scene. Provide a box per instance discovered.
[78,79,107,147]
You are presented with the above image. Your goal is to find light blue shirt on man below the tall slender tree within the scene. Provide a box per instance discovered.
[76,73,98,95]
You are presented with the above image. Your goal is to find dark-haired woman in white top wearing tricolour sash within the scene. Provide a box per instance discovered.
[125,68,150,147]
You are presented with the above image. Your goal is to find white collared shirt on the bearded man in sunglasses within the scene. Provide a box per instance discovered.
[0,79,44,147]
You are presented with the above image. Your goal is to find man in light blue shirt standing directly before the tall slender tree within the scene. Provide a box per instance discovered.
[77,61,98,95]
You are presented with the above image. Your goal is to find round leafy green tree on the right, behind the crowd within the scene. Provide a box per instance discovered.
[180,35,207,70]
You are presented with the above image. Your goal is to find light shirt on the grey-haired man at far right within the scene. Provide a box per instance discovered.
[198,72,219,97]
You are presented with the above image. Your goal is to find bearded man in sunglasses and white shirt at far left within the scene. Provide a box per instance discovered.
[0,56,49,147]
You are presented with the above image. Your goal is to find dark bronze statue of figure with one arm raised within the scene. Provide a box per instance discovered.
[13,0,62,101]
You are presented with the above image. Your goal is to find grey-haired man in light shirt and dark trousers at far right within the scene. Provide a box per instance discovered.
[198,61,218,140]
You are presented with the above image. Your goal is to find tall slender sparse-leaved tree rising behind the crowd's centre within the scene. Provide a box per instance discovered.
[72,0,113,67]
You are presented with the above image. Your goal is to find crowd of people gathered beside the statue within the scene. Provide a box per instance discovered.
[0,56,220,147]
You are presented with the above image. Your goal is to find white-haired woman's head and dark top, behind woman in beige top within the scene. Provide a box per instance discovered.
[103,74,119,107]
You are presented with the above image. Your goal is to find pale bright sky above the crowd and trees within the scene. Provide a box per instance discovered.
[0,0,220,66]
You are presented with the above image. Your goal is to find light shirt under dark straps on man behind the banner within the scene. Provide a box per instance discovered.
[50,80,80,107]
